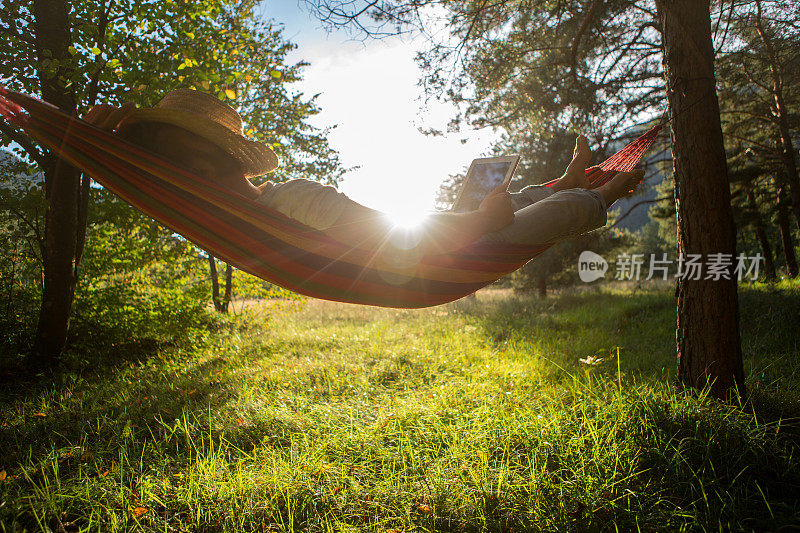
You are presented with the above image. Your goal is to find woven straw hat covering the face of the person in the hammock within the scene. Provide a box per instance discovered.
[117,89,278,177]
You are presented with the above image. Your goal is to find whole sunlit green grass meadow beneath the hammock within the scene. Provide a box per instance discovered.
[0,284,800,532]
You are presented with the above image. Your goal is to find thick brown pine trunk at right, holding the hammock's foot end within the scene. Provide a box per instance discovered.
[656,0,745,398]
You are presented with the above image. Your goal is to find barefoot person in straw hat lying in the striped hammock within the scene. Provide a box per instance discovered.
[84,89,644,254]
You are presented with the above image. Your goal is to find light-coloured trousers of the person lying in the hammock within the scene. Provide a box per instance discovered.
[480,185,606,246]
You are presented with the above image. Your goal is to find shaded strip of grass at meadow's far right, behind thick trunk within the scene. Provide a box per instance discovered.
[453,285,800,382]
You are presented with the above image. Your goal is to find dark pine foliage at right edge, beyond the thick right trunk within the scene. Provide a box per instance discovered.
[717,2,800,275]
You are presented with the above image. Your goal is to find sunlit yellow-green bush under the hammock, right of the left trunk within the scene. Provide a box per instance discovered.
[74,210,208,345]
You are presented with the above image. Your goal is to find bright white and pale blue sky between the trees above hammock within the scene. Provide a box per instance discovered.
[261,0,495,222]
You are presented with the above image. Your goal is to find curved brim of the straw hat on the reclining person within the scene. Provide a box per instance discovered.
[117,107,279,178]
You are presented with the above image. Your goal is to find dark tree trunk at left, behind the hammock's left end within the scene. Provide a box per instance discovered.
[30,0,81,367]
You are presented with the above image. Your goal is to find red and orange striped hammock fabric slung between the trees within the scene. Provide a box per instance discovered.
[0,87,660,308]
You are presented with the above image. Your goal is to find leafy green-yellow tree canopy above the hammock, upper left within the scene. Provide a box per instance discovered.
[0,0,342,183]
